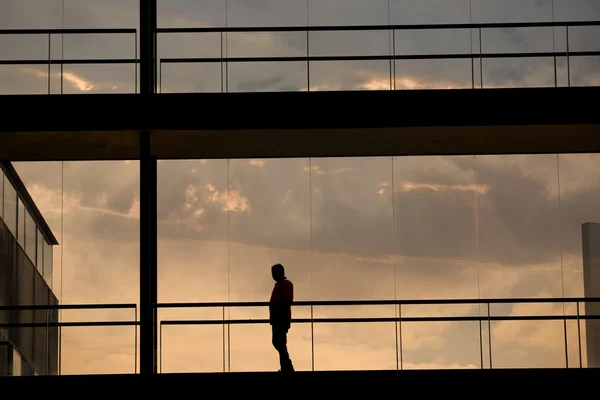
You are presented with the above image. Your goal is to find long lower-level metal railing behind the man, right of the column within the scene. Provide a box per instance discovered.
[155,298,600,372]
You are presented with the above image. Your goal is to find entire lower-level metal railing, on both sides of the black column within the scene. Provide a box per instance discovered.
[0,298,600,373]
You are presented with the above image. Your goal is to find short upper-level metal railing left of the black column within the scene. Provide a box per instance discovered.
[0,28,139,94]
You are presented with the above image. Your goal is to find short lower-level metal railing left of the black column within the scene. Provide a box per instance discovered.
[0,304,140,375]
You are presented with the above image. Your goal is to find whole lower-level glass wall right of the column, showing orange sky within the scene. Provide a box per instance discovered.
[158,154,600,372]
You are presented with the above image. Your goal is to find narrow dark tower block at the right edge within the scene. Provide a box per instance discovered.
[581,222,600,368]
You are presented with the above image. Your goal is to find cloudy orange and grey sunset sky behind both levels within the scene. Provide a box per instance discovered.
[0,0,600,373]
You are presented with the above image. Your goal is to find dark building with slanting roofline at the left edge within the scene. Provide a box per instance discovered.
[0,162,59,376]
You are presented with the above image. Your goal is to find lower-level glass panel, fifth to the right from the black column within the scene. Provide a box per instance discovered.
[476,154,566,368]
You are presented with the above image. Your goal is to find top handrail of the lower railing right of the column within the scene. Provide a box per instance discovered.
[154,297,600,308]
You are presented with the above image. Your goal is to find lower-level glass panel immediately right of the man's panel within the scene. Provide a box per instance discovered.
[310,157,397,370]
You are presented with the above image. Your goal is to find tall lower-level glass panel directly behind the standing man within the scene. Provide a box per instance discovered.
[229,159,312,371]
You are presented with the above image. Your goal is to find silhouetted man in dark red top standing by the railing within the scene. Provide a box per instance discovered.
[269,264,294,372]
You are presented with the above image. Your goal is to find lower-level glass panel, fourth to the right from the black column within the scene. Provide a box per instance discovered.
[391,156,481,369]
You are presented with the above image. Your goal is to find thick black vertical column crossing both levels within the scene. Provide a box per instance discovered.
[139,0,157,375]
